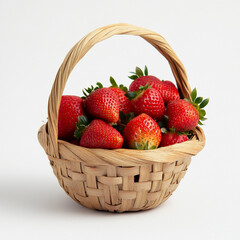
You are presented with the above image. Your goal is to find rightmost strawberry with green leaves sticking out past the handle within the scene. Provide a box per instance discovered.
[166,88,209,132]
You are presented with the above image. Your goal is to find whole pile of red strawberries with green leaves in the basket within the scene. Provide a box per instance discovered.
[58,66,209,150]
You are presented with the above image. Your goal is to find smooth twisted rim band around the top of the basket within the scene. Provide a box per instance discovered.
[38,124,205,166]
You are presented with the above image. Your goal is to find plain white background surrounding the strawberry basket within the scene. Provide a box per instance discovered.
[0,0,240,240]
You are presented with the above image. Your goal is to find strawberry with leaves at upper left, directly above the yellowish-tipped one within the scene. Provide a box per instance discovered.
[126,83,165,120]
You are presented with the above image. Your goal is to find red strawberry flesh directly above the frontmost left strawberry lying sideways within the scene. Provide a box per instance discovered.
[85,88,119,123]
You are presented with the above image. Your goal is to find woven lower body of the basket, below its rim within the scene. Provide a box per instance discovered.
[50,154,190,212]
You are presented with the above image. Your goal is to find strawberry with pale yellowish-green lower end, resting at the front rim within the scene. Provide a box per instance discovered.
[123,113,161,150]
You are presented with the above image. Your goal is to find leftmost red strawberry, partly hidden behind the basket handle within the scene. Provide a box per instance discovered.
[58,95,85,141]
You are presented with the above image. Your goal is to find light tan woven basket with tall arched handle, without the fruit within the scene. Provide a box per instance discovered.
[38,23,205,212]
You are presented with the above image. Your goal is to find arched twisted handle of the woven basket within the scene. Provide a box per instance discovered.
[47,23,191,157]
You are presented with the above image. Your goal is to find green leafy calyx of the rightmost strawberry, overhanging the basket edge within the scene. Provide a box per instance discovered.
[187,88,209,125]
